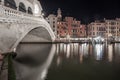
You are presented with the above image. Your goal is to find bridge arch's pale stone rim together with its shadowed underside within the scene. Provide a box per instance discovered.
[10,26,55,52]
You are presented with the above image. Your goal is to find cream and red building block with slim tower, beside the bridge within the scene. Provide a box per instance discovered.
[46,8,86,38]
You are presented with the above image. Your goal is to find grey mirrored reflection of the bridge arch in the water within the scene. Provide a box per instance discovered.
[14,44,55,80]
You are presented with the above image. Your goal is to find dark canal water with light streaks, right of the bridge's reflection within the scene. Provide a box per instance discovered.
[47,43,120,80]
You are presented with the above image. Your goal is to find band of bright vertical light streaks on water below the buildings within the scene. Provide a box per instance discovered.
[53,43,120,63]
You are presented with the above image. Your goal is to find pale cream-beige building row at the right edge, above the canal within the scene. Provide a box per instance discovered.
[87,18,120,38]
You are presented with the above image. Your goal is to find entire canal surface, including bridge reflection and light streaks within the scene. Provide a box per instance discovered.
[14,43,120,80]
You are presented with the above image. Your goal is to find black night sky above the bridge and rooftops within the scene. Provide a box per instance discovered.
[40,0,120,23]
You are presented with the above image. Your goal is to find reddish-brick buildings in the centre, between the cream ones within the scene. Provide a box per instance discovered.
[57,17,86,38]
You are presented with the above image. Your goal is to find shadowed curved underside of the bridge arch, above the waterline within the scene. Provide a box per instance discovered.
[21,27,52,42]
